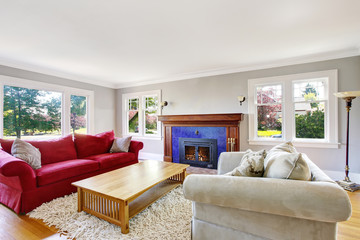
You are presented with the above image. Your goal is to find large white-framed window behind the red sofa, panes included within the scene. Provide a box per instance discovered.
[0,76,93,140]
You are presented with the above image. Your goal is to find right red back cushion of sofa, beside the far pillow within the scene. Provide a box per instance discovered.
[74,131,114,158]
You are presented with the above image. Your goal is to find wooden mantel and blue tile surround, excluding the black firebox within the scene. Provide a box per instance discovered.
[158,113,243,163]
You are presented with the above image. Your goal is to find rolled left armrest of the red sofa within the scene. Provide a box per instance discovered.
[0,150,36,191]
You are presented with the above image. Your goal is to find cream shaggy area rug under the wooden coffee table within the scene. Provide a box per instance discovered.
[28,186,192,240]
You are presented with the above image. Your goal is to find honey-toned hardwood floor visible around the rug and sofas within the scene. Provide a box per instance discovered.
[0,167,360,240]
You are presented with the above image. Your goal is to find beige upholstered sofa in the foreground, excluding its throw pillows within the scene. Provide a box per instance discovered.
[184,152,351,240]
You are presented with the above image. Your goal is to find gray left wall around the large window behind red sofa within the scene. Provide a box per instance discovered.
[0,65,116,133]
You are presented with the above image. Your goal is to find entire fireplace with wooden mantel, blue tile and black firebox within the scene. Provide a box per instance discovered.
[158,113,243,168]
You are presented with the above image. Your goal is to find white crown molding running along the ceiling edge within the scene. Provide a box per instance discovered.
[0,46,360,89]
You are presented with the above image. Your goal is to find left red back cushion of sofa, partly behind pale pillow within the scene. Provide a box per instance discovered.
[0,135,77,165]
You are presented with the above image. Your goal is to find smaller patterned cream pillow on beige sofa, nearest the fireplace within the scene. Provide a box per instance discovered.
[231,149,266,177]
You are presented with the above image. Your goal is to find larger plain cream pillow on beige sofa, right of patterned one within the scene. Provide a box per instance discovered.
[264,152,311,181]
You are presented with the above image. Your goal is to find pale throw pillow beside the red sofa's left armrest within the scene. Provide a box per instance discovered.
[11,138,41,169]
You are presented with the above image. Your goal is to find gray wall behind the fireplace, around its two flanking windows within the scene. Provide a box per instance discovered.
[116,56,360,173]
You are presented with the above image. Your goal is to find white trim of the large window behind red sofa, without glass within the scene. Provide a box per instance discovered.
[0,75,95,138]
